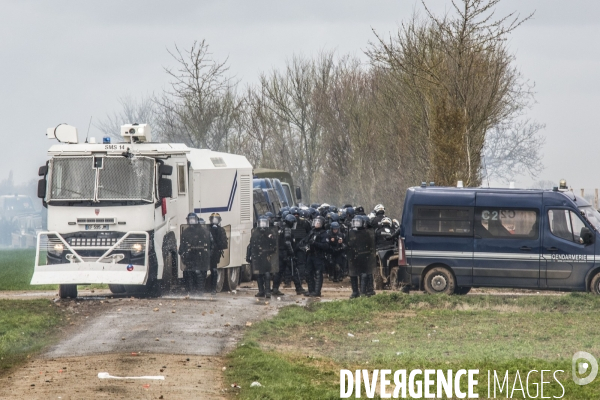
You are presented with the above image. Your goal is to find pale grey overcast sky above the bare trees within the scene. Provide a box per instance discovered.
[0,0,600,189]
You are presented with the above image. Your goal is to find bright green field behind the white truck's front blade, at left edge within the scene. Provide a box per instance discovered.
[0,249,108,290]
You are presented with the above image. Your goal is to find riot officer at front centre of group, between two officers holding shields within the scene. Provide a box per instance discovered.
[306,216,329,297]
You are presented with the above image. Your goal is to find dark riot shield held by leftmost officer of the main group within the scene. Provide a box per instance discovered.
[250,226,279,274]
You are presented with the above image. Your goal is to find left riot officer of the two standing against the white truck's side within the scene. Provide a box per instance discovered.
[178,213,213,294]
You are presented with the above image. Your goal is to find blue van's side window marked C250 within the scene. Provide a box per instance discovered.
[475,207,540,239]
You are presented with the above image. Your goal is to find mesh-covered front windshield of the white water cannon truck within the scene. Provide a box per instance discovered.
[48,157,154,202]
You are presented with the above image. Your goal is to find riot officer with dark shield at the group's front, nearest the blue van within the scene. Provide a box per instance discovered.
[348,215,376,299]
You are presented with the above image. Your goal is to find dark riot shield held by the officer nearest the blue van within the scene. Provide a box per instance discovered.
[348,229,377,276]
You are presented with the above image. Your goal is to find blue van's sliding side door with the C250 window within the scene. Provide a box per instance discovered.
[473,192,542,288]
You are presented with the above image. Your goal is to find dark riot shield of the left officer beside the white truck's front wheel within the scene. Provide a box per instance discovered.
[179,224,212,271]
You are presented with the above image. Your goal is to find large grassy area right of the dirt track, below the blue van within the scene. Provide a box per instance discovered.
[226,293,600,399]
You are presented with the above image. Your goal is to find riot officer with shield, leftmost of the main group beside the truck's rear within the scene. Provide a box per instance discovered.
[246,215,279,298]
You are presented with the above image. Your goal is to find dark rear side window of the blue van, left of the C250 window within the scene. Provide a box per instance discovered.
[413,206,473,236]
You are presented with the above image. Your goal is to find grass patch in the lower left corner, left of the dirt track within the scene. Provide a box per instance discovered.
[0,300,61,373]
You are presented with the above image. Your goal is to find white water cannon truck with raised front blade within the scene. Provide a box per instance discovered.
[31,124,253,298]
